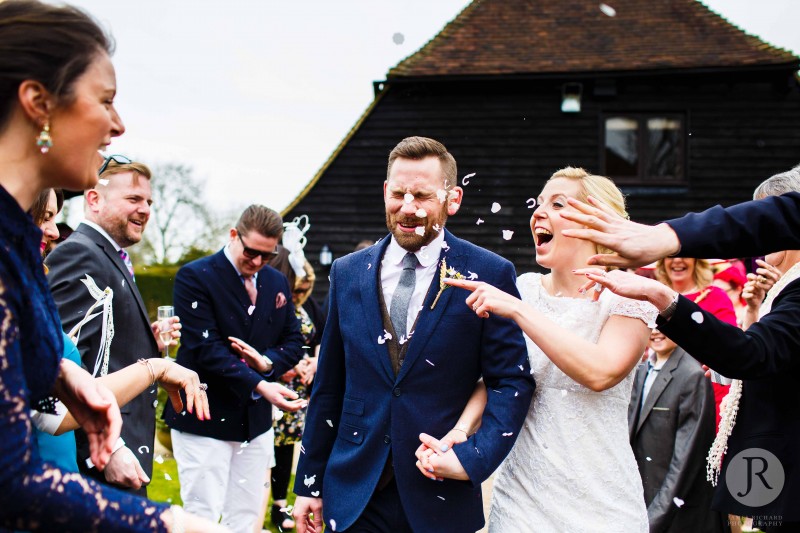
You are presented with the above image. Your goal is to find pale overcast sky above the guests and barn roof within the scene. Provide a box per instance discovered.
[71,0,800,217]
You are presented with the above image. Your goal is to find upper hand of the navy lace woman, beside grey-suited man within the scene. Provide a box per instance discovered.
[54,359,122,470]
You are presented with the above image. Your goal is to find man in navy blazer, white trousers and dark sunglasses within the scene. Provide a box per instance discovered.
[164,205,305,531]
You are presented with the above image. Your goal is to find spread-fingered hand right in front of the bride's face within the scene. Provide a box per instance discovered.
[561,196,680,268]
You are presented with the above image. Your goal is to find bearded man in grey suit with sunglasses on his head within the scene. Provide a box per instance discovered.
[45,156,177,495]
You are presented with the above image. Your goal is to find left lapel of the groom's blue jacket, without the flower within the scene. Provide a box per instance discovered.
[359,236,395,383]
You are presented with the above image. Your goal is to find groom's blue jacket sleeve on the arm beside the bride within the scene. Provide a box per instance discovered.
[453,261,536,487]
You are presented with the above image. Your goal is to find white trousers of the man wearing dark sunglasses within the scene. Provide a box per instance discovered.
[171,429,275,533]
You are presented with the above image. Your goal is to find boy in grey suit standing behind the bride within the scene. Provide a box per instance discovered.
[628,330,722,533]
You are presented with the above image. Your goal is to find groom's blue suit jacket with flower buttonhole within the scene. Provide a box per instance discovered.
[294,231,534,532]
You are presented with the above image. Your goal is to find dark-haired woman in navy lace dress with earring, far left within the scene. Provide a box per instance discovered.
[0,0,221,532]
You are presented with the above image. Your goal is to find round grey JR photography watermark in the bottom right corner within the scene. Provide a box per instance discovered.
[725,448,786,507]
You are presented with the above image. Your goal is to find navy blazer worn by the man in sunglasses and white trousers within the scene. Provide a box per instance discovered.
[164,250,303,442]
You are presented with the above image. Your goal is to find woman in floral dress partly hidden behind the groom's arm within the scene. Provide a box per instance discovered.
[270,261,325,531]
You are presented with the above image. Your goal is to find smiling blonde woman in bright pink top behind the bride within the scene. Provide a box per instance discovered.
[655,257,736,428]
